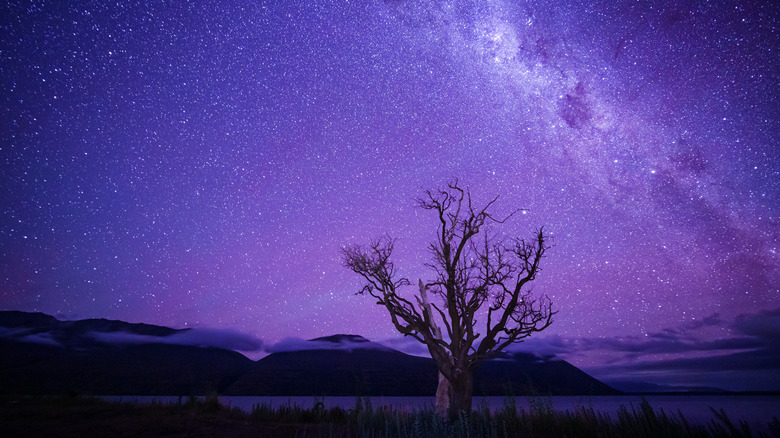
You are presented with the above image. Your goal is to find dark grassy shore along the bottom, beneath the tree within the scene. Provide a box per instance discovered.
[0,395,780,438]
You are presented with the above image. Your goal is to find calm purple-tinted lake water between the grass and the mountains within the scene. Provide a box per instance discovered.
[105,395,780,432]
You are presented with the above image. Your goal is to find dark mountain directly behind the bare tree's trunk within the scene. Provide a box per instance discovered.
[225,335,619,396]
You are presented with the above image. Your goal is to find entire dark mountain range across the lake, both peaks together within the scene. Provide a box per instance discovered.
[0,312,617,396]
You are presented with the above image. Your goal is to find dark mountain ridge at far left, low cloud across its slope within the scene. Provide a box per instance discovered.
[0,312,252,395]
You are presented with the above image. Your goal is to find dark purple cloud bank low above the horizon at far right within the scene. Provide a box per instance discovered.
[569,308,780,390]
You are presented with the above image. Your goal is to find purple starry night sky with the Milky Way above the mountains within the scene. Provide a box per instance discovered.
[0,0,780,389]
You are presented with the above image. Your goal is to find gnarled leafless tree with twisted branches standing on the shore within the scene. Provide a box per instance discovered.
[342,180,556,417]
